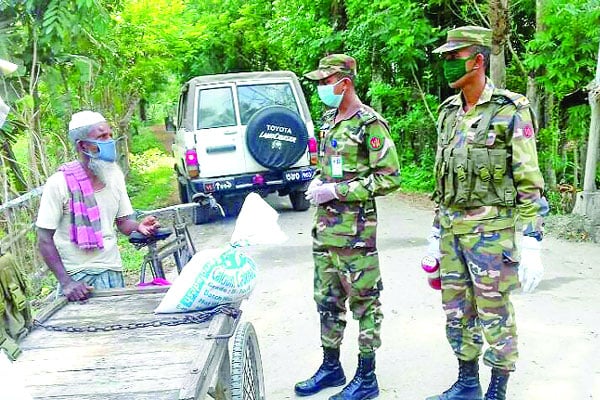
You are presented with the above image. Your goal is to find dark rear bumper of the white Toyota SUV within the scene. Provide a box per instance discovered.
[185,166,316,197]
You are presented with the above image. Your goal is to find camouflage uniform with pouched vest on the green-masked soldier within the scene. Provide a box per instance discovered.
[434,73,548,371]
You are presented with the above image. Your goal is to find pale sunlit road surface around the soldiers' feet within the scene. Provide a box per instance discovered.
[189,192,600,400]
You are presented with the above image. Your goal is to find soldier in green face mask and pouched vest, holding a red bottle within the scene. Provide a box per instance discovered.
[428,26,548,400]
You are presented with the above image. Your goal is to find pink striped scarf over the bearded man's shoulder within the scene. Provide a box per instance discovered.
[58,161,104,249]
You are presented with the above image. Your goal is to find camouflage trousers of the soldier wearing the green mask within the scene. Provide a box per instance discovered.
[440,228,519,371]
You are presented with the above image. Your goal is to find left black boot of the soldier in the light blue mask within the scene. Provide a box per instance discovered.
[294,347,346,396]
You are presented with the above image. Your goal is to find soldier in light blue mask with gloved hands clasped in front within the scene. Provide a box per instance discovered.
[295,54,400,400]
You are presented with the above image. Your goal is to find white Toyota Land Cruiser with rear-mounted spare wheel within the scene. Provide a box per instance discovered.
[173,71,317,223]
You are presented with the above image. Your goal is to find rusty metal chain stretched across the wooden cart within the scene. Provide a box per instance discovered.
[33,305,240,333]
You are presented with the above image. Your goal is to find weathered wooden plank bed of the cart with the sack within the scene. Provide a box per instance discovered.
[17,288,234,400]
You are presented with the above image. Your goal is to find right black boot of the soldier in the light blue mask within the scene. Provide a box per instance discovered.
[329,353,379,400]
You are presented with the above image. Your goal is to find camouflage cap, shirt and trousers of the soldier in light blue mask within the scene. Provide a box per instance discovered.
[305,54,400,354]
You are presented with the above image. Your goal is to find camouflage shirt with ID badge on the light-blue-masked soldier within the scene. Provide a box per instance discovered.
[313,105,400,248]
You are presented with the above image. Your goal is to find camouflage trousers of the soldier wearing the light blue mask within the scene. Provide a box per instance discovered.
[313,247,383,354]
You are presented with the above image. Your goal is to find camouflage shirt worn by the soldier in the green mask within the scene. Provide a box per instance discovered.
[434,79,548,234]
